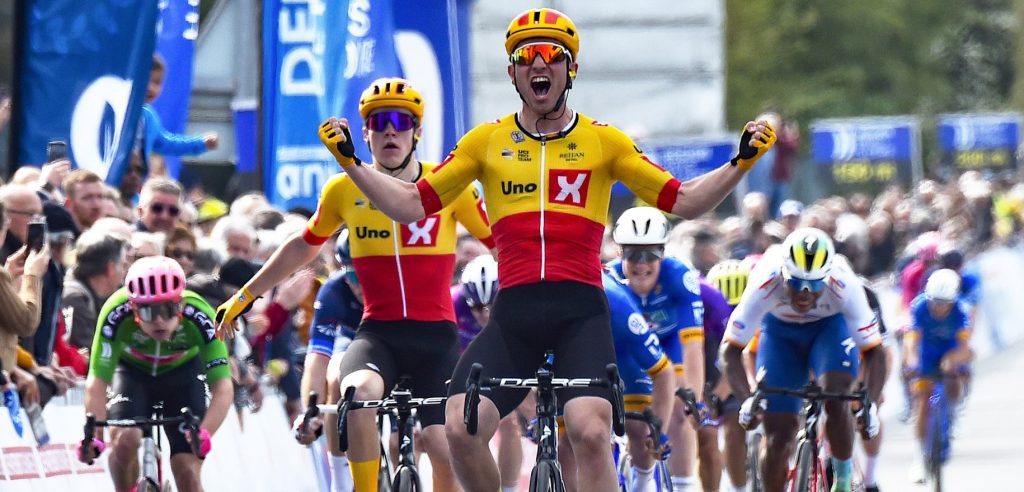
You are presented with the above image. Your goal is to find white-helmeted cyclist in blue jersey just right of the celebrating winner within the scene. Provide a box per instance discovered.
[608,207,705,490]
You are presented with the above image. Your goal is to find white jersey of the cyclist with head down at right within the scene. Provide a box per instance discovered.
[725,246,882,351]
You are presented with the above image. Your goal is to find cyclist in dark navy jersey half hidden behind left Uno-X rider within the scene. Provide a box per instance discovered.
[295,229,362,492]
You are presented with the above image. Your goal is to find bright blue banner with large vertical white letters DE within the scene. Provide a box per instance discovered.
[263,0,401,209]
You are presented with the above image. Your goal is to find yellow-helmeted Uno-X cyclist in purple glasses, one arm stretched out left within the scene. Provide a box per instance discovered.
[217,78,497,492]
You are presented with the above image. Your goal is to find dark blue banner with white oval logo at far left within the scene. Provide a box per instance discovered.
[15,0,157,185]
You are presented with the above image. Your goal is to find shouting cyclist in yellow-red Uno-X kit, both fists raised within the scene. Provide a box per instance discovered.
[319,8,775,491]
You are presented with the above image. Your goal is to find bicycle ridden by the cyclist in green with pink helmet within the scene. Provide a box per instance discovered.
[81,404,200,492]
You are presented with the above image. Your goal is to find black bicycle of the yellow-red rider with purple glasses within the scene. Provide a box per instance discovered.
[302,376,447,492]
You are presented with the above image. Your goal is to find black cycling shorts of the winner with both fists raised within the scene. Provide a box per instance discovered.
[449,282,615,417]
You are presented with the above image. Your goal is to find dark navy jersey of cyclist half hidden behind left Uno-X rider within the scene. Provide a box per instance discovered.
[307,272,362,358]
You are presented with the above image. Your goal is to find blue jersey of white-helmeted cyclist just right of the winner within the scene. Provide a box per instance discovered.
[608,256,705,341]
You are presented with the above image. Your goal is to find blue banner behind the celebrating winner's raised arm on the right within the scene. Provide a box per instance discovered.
[611,137,736,196]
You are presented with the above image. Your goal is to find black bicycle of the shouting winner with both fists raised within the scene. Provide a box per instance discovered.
[463,353,626,492]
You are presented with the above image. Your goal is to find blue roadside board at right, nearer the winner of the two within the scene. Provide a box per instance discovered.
[811,117,922,193]
